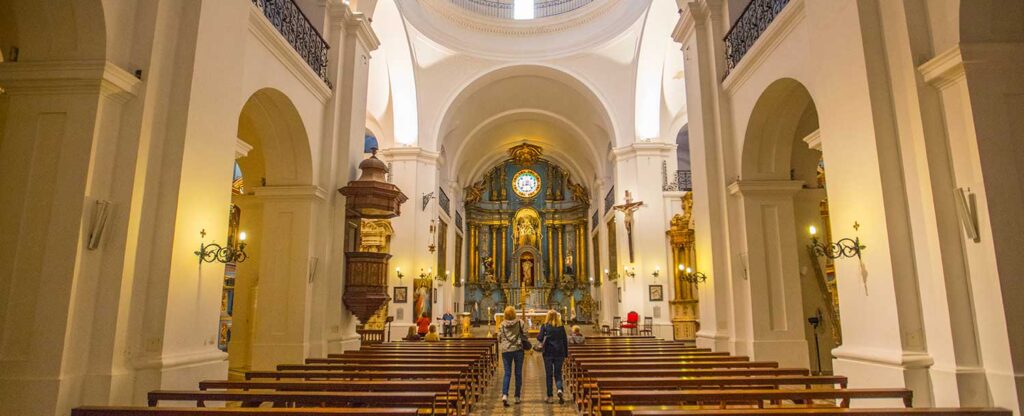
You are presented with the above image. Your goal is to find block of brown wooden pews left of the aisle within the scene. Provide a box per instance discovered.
[72,339,498,416]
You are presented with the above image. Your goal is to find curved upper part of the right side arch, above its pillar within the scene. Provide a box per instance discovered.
[740,78,818,180]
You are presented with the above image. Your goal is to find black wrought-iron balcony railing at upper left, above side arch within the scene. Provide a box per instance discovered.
[252,0,332,88]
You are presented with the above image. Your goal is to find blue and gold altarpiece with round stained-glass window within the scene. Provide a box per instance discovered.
[463,142,594,322]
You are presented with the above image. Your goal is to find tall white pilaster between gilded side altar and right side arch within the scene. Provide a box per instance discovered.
[673,0,745,350]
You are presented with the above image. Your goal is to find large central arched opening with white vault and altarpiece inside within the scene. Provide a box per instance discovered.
[437,66,614,322]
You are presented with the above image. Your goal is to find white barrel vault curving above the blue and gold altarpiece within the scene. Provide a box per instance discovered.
[436,66,614,190]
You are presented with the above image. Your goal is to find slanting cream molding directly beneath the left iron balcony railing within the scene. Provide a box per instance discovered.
[249,2,331,103]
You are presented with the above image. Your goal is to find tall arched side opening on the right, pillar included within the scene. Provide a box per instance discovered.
[733,79,842,373]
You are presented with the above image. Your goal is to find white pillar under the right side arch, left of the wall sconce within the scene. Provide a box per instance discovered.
[729,180,808,368]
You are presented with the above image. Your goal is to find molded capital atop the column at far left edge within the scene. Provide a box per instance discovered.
[0,60,142,102]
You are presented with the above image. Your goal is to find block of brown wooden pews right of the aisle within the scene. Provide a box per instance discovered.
[563,338,1011,416]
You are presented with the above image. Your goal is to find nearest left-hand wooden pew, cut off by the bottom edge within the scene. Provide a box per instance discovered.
[71,406,430,416]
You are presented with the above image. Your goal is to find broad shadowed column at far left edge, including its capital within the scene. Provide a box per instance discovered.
[0,61,140,414]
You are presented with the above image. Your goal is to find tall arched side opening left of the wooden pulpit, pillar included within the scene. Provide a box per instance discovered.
[226,88,313,374]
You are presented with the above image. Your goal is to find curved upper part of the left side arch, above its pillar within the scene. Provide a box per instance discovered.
[239,88,313,185]
